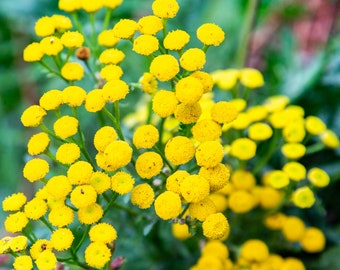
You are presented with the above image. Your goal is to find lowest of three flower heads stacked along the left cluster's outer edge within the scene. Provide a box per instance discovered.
[23,158,50,182]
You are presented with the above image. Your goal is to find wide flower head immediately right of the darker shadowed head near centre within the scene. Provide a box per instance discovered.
[210,101,238,124]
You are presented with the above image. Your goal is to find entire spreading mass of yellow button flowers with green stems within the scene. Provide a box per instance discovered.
[0,0,339,270]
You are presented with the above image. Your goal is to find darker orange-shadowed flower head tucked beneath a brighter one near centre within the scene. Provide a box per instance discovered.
[174,102,202,124]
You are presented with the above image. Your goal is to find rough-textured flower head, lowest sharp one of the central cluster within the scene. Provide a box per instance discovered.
[202,213,230,240]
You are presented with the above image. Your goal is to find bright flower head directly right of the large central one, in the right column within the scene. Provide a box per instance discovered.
[195,141,224,168]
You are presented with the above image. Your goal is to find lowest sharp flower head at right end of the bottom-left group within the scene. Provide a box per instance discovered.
[85,242,111,268]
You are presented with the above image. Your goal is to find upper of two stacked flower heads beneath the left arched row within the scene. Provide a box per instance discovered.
[53,115,78,139]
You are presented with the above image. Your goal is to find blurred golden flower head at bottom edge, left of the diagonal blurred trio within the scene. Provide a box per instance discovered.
[241,239,269,262]
